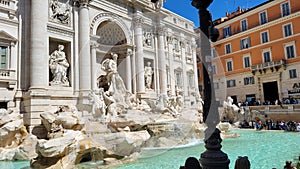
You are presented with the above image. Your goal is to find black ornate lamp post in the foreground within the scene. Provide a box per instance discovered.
[180,0,230,169]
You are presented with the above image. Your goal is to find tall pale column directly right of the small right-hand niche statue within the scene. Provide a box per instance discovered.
[158,26,167,94]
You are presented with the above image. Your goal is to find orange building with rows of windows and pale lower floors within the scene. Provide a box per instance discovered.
[198,0,300,104]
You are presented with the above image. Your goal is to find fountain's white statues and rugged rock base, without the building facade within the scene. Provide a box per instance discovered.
[0,52,211,168]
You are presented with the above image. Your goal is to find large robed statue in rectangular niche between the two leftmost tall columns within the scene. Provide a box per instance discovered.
[49,45,69,86]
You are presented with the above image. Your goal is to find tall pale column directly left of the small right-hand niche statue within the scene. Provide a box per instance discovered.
[134,16,145,93]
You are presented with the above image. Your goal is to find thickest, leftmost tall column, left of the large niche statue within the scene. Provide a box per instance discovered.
[30,0,49,89]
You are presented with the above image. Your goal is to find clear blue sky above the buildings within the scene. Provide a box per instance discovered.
[164,0,268,27]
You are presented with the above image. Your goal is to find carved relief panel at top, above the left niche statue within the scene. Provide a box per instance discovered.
[50,0,71,24]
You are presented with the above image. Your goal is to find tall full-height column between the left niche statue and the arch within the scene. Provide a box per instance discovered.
[76,0,91,91]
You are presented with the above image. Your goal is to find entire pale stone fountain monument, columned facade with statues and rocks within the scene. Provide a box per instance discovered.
[0,0,202,168]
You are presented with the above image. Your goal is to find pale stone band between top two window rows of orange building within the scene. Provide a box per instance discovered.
[213,11,300,46]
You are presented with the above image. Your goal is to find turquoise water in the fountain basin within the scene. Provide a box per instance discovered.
[0,130,300,169]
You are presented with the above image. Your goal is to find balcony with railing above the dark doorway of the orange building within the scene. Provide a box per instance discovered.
[251,60,285,74]
